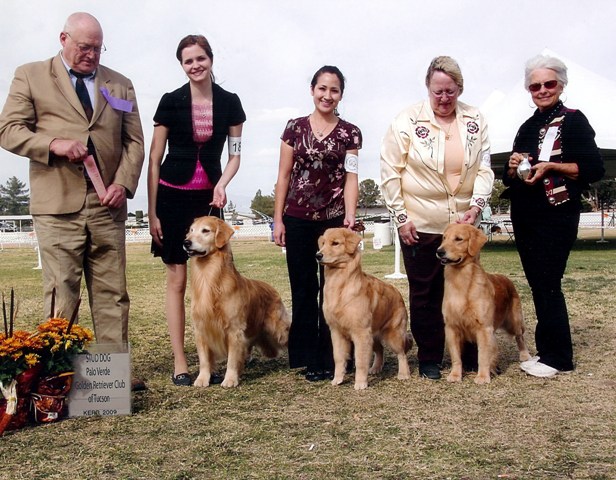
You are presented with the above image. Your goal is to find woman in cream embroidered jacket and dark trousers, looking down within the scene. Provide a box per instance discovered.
[381,57,494,380]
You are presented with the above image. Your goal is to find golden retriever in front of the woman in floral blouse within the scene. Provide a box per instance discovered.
[317,228,412,390]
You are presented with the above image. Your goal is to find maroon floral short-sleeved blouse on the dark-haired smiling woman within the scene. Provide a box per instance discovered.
[281,117,362,221]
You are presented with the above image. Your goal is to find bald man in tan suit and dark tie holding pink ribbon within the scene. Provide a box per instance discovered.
[0,13,144,356]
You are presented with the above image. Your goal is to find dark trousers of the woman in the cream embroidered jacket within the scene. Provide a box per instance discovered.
[400,232,477,368]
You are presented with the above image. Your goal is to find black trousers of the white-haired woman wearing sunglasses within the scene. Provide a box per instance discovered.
[511,207,580,371]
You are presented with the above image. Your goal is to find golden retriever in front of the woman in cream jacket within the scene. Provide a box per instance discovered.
[436,223,530,384]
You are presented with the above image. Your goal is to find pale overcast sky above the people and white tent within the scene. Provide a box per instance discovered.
[0,0,616,211]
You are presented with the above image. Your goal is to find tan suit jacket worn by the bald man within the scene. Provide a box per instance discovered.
[0,54,144,221]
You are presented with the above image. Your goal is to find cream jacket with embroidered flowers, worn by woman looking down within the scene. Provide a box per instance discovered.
[381,100,494,234]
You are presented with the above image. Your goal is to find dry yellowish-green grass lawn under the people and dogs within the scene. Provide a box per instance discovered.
[0,232,616,480]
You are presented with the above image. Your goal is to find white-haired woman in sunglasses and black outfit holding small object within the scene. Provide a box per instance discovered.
[503,55,605,377]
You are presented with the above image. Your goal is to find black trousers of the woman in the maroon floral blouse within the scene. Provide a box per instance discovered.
[283,216,344,372]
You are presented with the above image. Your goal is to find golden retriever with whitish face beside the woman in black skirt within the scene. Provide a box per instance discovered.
[184,217,291,387]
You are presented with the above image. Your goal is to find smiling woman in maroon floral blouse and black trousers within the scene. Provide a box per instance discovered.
[274,66,362,381]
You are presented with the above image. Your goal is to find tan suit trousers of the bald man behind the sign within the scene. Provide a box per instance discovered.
[33,188,129,344]
